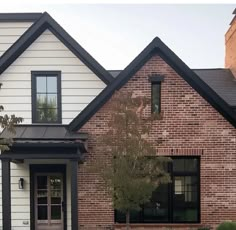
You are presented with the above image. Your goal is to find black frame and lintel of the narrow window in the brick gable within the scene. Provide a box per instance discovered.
[149,74,164,114]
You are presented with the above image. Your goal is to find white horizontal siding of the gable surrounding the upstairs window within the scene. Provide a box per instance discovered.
[0,30,106,124]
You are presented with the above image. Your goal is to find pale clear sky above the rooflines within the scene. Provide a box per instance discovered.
[0,0,236,70]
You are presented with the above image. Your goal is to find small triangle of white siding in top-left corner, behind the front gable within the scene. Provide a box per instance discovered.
[0,22,32,56]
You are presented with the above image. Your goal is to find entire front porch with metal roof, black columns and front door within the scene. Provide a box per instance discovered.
[0,125,87,230]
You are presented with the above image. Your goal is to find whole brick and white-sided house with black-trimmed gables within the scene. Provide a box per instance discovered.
[0,9,236,230]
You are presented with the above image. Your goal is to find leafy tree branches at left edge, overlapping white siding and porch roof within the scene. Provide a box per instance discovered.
[0,105,23,152]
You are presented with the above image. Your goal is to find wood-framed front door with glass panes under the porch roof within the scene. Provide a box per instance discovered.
[34,173,63,230]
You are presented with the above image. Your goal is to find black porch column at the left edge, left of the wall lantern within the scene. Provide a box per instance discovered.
[2,159,11,230]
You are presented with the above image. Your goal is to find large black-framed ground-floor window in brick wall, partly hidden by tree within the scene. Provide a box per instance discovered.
[115,157,200,223]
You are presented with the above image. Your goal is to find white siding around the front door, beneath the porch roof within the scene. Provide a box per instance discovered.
[0,160,71,230]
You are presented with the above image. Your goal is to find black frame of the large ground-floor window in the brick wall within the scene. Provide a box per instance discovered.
[114,156,201,224]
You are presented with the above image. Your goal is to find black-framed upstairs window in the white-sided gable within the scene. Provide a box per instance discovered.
[32,71,61,123]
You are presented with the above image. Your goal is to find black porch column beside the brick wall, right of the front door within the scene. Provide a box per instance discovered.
[71,159,79,230]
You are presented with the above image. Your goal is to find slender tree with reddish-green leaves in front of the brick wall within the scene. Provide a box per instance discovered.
[92,93,170,230]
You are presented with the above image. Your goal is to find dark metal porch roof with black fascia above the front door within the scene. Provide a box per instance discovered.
[0,125,88,161]
